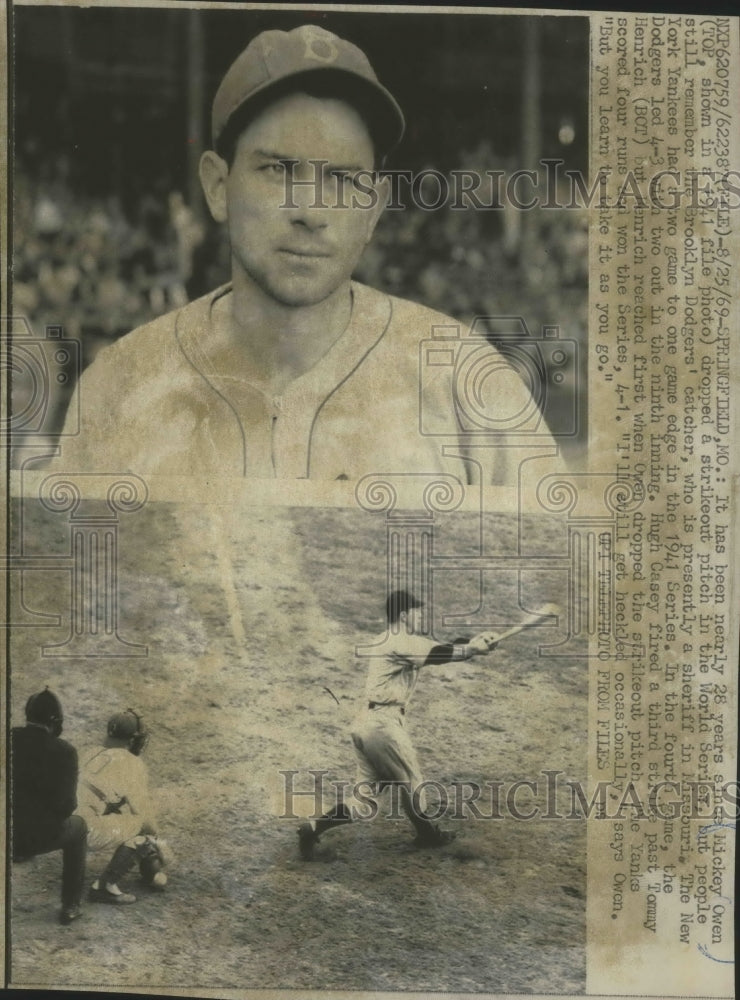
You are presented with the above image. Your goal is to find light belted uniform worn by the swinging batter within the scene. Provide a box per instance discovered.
[345,626,446,811]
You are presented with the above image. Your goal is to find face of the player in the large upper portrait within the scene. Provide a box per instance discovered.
[211,94,382,306]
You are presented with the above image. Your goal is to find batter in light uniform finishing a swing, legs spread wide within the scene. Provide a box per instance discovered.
[298,590,498,861]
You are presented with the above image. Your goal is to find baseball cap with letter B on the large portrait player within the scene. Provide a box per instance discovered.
[211,24,405,155]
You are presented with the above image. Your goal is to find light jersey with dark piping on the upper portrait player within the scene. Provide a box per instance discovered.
[53,282,557,485]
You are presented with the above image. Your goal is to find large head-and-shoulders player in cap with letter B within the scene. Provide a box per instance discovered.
[52,18,559,485]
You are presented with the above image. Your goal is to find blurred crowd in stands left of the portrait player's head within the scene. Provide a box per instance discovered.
[13,156,212,362]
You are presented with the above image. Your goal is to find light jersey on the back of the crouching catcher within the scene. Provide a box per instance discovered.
[77,747,156,851]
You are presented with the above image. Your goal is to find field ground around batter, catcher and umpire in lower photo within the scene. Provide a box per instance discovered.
[9,502,587,995]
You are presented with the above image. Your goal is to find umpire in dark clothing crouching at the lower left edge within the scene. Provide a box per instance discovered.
[11,687,87,924]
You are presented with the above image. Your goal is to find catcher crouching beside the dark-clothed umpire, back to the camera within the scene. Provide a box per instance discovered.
[80,708,167,906]
